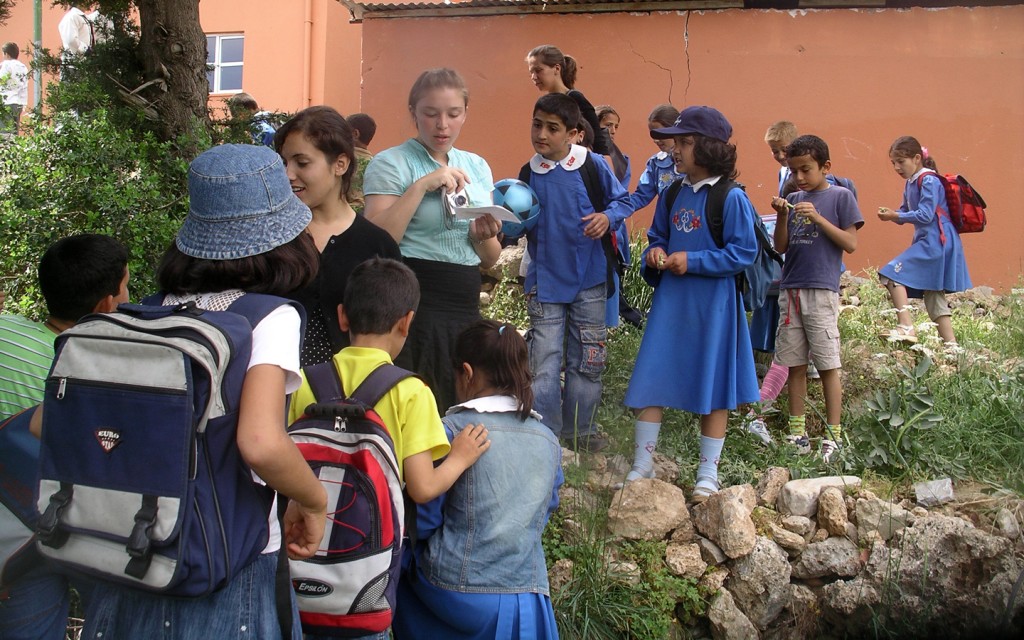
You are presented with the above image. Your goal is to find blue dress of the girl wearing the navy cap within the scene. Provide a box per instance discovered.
[625,178,760,415]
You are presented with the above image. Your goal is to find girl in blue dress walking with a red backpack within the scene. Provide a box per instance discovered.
[879,135,972,344]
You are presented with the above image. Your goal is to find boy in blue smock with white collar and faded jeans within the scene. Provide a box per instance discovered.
[525,93,633,452]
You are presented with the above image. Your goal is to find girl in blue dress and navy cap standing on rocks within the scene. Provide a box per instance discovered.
[625,106,758,502]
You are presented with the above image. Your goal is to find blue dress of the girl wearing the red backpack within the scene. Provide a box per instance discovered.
[879,169,972,298]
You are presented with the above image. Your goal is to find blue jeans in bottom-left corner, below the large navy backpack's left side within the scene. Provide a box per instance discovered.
[0,566,71,640]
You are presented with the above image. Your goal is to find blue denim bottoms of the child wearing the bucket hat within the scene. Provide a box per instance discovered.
[82,553,302,640]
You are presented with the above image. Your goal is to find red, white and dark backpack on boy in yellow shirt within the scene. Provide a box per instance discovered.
[288,360,415,638]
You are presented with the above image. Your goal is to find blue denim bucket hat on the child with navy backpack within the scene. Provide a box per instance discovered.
[175,144,312,260]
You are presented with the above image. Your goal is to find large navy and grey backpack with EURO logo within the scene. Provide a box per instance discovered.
[37,294,288,596]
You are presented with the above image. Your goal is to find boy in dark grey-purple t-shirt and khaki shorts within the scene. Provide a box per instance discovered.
[771,135,864,462]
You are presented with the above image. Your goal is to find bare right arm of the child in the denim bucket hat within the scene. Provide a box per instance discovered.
[237,365,327,558]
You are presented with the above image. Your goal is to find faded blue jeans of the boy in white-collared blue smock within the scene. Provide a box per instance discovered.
[526,283,608,438]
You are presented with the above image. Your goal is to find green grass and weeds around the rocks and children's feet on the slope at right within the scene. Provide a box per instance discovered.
[484,230,1024,639]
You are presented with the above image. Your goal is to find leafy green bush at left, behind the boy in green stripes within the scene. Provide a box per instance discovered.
[0,109,187,317]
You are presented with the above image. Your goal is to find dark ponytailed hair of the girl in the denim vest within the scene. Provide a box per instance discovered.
[455,319,534,420]
